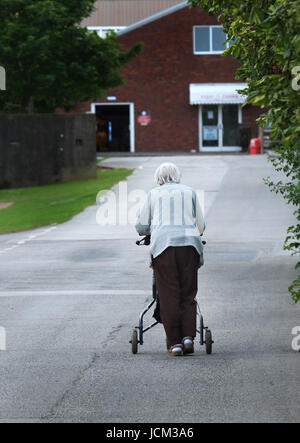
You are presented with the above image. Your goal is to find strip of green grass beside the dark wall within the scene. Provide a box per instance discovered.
[0,168,132,234]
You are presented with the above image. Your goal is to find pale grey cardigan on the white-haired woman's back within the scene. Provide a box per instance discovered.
[136,183,205,258]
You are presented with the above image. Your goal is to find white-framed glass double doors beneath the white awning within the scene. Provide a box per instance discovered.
[199,105,242,151]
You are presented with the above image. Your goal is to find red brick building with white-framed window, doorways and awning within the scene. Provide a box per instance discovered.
[76,2,260,152]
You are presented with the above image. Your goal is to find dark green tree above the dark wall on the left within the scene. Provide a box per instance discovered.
[0,0,141,112]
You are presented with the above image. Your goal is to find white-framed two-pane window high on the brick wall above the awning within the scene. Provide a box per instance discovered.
[194,26,230,54]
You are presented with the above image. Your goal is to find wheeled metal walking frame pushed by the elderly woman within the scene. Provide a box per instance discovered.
[130,236,214,355]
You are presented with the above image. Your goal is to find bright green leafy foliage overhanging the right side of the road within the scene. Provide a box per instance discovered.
[190,0,300,302]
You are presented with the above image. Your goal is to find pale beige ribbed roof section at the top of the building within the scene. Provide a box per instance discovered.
[82,0,186,27]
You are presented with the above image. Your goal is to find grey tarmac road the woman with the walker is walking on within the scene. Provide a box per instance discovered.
[0,156,300,423]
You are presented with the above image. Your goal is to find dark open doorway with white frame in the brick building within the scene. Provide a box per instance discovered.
[96,105,130,152]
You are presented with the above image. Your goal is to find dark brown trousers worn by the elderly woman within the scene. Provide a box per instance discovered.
[153,246,200,345]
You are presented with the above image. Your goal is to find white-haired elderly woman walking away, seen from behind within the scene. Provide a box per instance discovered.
[136,163,205,356]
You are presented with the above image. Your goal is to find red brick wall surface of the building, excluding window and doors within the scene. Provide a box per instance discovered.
[76,7,257,152]
